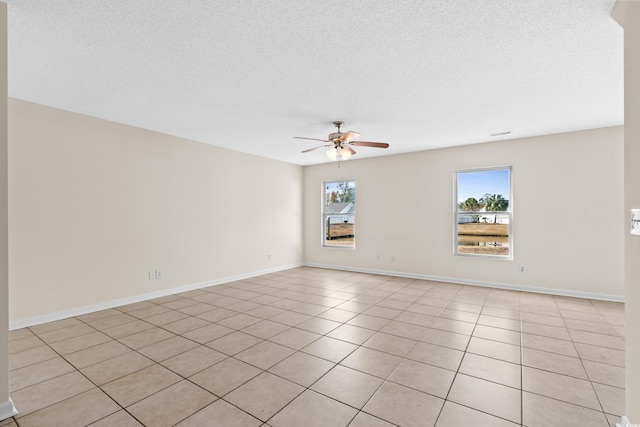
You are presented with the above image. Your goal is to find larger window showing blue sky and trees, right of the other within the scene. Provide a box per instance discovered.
[454,167,513,259]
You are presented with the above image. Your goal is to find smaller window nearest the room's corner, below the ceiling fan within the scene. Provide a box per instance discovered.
[322,181,356,248]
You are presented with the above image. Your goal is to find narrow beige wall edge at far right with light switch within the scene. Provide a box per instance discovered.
[614,1,640,423]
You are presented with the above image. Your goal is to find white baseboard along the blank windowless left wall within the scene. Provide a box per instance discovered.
[9,263,304,331]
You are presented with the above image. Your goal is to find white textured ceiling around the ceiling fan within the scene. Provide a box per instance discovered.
[4,0,623,165]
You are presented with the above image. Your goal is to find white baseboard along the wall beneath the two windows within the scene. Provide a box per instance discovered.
[304,262,624,302]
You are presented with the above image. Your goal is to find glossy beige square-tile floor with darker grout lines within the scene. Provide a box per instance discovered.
[5,267,624,427]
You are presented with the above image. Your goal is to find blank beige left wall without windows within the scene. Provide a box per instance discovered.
[9,99,303,325]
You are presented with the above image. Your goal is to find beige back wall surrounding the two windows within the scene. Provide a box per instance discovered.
[304,127,623,299]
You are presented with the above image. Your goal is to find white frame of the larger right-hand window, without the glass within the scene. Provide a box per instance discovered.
[453,166,514,261]
